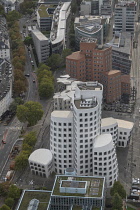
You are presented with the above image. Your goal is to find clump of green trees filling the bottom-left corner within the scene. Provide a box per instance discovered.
[0,182,21,210]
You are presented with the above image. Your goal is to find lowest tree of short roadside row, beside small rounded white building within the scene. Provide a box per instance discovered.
[15,151,30,171]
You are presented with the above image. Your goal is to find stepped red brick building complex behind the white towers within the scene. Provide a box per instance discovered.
[66,38,130,103]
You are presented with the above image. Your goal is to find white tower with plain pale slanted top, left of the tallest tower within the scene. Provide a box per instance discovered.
[50,111,73,174]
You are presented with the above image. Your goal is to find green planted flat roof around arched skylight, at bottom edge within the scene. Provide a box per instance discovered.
[19,191,51,210]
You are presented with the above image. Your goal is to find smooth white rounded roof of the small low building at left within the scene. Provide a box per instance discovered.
[29,149,53,165]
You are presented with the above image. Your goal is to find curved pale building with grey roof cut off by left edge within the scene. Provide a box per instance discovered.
[0,58,12,116]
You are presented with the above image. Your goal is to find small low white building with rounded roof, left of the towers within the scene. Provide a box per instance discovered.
[28,149,53,177]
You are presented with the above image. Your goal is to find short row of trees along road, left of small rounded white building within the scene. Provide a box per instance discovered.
[15,131,37,171]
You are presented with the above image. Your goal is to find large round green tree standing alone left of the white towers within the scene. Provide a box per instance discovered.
[17,101,43,126]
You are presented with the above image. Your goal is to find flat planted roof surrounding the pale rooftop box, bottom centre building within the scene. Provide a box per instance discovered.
[52,175,105,198]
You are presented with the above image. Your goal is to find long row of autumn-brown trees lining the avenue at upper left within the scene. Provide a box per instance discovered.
[6,11,27,96]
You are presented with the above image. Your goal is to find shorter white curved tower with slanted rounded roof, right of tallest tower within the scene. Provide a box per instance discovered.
[93,134,118,187]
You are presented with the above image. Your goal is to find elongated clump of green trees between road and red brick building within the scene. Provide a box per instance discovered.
[37,64,54,98]
